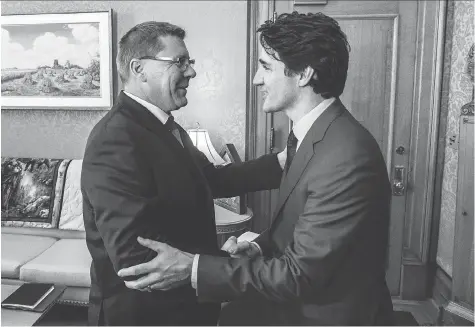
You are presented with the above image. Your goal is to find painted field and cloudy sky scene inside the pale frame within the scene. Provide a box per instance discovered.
[1,23,101,98]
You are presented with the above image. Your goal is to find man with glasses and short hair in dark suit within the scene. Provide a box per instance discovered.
[81,22,282,326]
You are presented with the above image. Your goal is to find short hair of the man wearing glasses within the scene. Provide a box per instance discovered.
[116,21,186,83]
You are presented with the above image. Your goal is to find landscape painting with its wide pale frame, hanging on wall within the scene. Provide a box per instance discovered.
[1,11,113,110]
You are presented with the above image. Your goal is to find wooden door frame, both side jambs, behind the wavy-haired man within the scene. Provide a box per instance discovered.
[246,0,447,300]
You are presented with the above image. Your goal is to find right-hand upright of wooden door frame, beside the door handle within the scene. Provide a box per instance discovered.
[400,0,447,300]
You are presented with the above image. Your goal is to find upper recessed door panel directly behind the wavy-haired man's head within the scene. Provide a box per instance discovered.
[338,16,397,159]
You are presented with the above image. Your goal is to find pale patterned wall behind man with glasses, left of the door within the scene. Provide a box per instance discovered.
[1,1,247,158]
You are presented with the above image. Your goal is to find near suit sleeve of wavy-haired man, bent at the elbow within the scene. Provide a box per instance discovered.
[198,148,389,302]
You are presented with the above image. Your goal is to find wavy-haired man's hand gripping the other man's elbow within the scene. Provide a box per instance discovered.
[118,237,193,291]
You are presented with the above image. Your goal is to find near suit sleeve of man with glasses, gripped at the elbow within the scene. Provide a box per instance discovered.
[81,128,166,278]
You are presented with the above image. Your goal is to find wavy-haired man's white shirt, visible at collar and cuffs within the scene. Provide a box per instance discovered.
[191,98,335,294]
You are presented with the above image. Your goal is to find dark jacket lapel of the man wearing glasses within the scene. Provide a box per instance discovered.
[118,92,209,187]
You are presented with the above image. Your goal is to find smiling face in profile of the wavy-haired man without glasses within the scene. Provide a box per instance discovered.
[253,50,299,113]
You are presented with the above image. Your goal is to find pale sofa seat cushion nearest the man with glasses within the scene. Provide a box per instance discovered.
[20,239,92,287]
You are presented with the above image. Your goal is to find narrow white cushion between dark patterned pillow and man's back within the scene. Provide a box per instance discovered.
[59,159,84,231]
